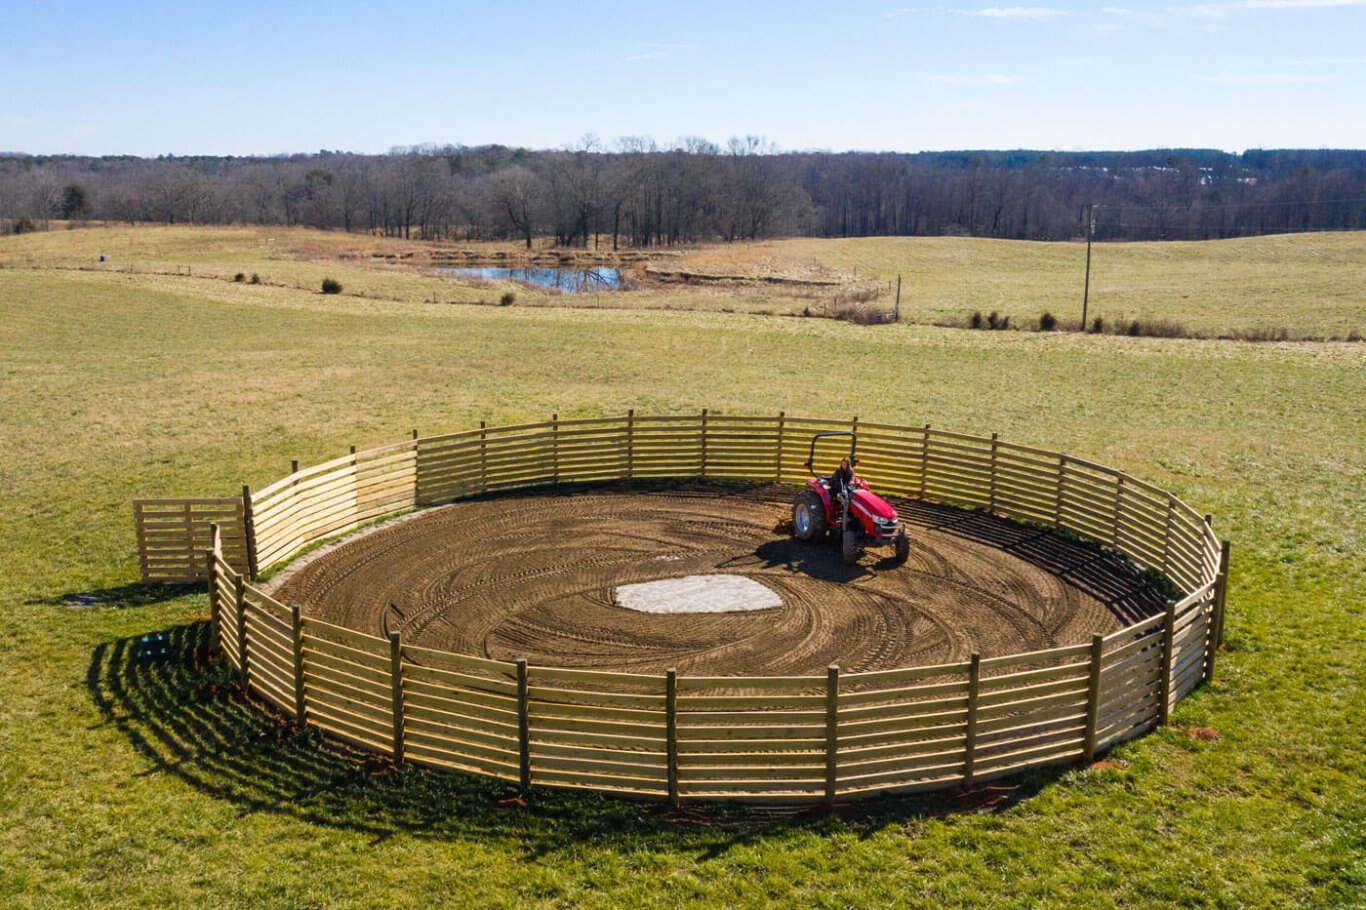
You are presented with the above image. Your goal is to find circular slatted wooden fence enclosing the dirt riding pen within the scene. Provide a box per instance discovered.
[187,411,1228,803]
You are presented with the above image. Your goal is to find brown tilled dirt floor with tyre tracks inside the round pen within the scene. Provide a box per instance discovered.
[272,485,1162,675]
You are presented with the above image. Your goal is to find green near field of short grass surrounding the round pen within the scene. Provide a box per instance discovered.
[0,232,1366,907]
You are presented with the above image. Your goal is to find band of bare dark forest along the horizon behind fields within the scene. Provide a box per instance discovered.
[0,137,1366,249]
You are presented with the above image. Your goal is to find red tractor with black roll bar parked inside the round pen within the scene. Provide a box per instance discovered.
[792,432,911,566]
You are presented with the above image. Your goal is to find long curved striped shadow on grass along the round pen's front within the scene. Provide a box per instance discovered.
[85,622,1063,859]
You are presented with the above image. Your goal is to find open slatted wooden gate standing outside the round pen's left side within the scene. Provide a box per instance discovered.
[133,497,247,583]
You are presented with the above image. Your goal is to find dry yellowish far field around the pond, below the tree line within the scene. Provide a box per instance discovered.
[0,227,1366,339]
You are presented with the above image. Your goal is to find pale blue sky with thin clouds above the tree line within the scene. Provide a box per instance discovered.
[0,0,1366,156]
